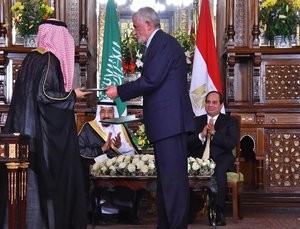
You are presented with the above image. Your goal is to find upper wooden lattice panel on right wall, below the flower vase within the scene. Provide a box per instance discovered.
[265,65,300,102]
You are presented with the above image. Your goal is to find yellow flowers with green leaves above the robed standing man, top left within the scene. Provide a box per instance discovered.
[10,0,53,37]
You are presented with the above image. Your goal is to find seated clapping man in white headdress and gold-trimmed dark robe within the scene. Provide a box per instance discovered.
[79,100,143,224]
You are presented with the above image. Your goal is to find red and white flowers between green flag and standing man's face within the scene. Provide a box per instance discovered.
[121,28,145,73]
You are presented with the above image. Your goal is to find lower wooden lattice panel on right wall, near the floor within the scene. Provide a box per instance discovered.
[268,132,300,187]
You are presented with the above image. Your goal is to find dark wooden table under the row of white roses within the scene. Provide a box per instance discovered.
[90,176,217,225]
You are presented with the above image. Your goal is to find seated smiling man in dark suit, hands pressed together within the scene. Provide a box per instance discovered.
[188,91,239,226]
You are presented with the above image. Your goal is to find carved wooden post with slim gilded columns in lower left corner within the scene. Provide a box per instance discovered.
[0,134,29,229]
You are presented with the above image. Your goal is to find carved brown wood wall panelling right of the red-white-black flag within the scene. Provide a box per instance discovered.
[223,0,300,193]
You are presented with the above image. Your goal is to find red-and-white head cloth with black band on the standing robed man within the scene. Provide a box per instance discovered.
[37,19,75,91]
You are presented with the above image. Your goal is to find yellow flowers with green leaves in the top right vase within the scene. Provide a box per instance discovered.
[260,0,300,40]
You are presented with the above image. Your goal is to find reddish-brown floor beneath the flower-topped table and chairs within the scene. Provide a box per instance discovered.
[87,206,300,229]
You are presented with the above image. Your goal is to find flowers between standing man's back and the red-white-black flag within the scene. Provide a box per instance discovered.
[174,29,195,72]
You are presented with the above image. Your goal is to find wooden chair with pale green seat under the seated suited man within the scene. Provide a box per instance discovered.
[227,115,244,222]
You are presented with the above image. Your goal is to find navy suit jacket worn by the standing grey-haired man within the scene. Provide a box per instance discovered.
[118,30,194,142]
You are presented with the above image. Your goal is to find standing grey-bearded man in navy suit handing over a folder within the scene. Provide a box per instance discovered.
[106,7,194,229]
